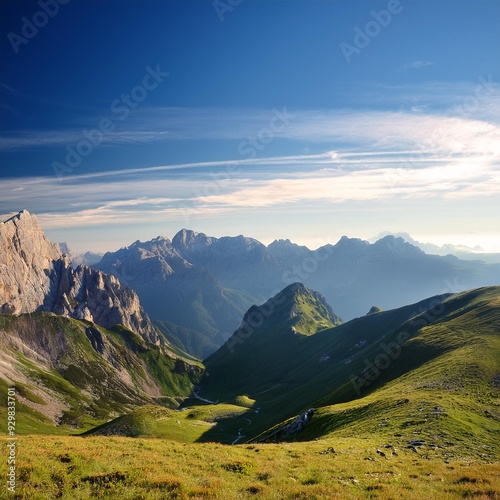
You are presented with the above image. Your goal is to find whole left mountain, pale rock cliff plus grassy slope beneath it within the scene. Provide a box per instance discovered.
[0,211,203,431]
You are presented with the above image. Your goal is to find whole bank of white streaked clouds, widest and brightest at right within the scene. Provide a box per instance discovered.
[0,102,500,234]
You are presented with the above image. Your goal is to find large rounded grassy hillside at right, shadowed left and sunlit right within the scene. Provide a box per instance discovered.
[197,287,500,446]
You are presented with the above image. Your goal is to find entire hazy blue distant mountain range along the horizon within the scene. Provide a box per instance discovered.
[94,225,500,359]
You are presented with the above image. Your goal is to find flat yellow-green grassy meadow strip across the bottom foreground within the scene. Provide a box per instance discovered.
[0,435,500,500]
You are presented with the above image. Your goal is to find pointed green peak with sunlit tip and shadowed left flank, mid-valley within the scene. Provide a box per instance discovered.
[201,284,341,399]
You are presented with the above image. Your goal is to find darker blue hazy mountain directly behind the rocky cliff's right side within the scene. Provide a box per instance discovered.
[94,233,253,358]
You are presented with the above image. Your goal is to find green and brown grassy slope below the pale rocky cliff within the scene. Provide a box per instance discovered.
[0,313,202,433]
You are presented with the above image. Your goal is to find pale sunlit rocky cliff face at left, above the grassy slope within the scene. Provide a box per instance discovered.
[0,210,159,343]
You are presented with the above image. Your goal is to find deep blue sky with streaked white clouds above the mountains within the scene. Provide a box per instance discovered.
[0,0,500,252]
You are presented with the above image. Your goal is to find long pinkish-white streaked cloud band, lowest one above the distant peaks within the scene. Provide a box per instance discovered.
[0,150,500,227]
